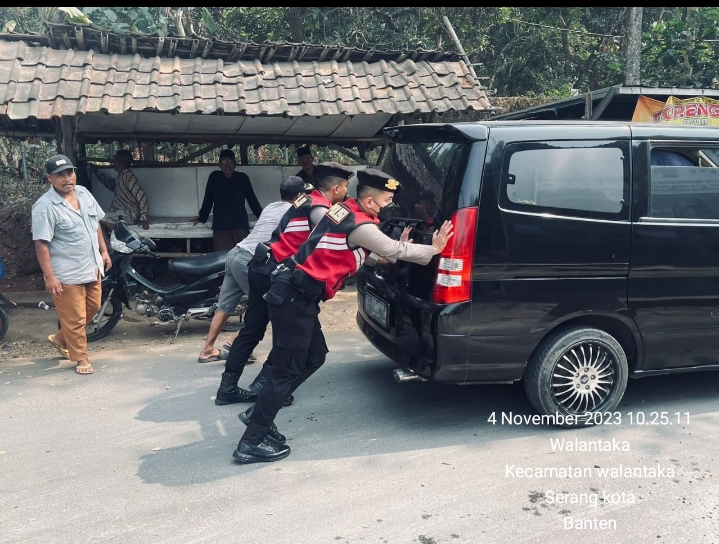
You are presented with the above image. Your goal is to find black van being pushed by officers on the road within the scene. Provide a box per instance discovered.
[357,121,719,424]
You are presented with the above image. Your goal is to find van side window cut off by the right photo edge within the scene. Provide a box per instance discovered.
[649,146,719,219]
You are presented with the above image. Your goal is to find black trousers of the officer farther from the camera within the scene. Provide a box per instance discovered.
[225,258,277,374]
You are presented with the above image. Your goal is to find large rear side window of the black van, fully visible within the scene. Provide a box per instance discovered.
[500,141,629,219]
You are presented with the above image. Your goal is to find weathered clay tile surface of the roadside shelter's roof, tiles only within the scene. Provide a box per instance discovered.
[0,38,491,121]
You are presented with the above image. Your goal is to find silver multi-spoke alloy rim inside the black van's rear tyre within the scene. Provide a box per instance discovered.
[552,341,617,414]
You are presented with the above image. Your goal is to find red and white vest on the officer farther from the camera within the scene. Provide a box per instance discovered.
[267,189,332,263]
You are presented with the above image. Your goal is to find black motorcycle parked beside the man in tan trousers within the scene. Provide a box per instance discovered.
[86,221,227,344]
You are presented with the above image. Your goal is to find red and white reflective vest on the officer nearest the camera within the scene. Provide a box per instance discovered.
[295,198,379,300]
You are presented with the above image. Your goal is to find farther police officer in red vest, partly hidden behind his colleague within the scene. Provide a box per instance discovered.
[215,162,354,406]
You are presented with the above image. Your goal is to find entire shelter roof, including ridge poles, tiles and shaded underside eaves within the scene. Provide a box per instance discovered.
[0,24,492,166]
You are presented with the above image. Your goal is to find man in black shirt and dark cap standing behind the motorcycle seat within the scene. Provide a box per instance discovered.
[192,149,262,251]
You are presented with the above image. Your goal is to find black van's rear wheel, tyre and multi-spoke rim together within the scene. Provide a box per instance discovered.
[524,327,628,427]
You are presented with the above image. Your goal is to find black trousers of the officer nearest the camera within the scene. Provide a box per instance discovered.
[241,273,328,445]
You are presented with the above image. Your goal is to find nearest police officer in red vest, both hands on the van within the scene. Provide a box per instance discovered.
[233,169,453,463]
